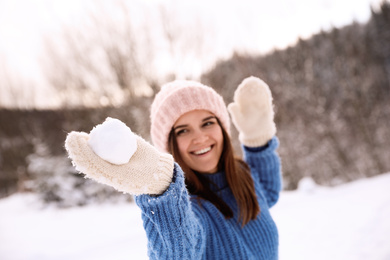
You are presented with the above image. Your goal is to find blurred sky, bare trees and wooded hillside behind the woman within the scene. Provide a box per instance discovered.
[0,0,390,212]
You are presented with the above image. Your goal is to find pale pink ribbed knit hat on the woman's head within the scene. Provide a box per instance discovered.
[150,80,230,152]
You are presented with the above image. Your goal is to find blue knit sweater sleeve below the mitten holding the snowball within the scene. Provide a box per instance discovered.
[135,163,205,259]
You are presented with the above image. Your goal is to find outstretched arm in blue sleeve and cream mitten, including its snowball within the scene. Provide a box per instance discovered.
[65,119,205,259]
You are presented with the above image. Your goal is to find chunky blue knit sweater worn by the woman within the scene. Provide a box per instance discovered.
[135,137,281,260]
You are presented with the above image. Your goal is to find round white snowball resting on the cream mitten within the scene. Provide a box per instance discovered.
[88,117,137,165]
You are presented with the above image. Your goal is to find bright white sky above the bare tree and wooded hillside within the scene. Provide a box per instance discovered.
[0,0,381,106]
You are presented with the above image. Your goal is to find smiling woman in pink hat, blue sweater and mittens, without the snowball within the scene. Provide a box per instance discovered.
[65,77,281,259]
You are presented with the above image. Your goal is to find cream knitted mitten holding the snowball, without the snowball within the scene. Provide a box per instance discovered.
[65,132,174,195]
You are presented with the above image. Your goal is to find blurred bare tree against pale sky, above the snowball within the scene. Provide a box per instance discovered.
[44,1,156,106]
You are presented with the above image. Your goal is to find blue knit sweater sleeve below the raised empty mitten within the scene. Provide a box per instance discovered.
[243,136,282,207]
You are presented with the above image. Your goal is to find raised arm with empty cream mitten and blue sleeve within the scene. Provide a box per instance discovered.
[228,77,281,207]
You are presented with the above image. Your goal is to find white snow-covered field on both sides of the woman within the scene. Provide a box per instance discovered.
[0,173,390,260]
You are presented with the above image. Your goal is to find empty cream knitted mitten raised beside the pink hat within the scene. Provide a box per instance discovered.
[228,77,276,147]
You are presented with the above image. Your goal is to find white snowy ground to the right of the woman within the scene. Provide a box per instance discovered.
[272,173,390,260]
